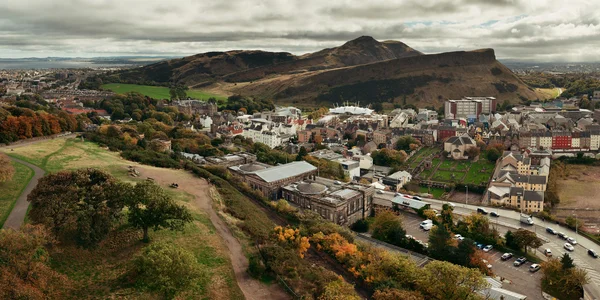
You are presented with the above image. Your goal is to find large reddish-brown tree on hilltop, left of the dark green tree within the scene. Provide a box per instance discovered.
[27,169,126,246]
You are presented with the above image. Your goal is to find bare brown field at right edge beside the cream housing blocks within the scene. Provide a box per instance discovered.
[552,165,600,224]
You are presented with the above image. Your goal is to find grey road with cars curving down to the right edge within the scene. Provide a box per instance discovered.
[423,199,600,299]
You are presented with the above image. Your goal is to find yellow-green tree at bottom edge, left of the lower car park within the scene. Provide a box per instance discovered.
[417,261,487,300]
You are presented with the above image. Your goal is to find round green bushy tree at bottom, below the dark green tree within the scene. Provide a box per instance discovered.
[131,243,202,298]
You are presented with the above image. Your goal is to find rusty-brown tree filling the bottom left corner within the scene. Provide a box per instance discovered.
[0,225,71,300]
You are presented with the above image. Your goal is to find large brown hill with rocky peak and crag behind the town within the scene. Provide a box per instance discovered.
[101,36,538,107]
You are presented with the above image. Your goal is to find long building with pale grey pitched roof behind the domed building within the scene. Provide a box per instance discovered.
[229,161,317,200]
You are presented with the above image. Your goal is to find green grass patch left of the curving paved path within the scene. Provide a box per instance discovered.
[0,162,33,228]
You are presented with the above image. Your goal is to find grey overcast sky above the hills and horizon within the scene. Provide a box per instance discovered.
[0,0,600,62]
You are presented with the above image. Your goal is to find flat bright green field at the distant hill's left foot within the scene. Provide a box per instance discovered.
[102,83,227,100]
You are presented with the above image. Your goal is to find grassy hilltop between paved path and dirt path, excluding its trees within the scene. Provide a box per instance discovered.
[0,139,244,299]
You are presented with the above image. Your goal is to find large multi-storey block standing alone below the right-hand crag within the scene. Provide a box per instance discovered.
[444,97,496,120]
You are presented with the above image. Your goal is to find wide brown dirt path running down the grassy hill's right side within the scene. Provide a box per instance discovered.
[136,166,290,300]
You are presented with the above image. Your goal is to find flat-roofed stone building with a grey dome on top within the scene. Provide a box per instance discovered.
[281,176,375,226]
